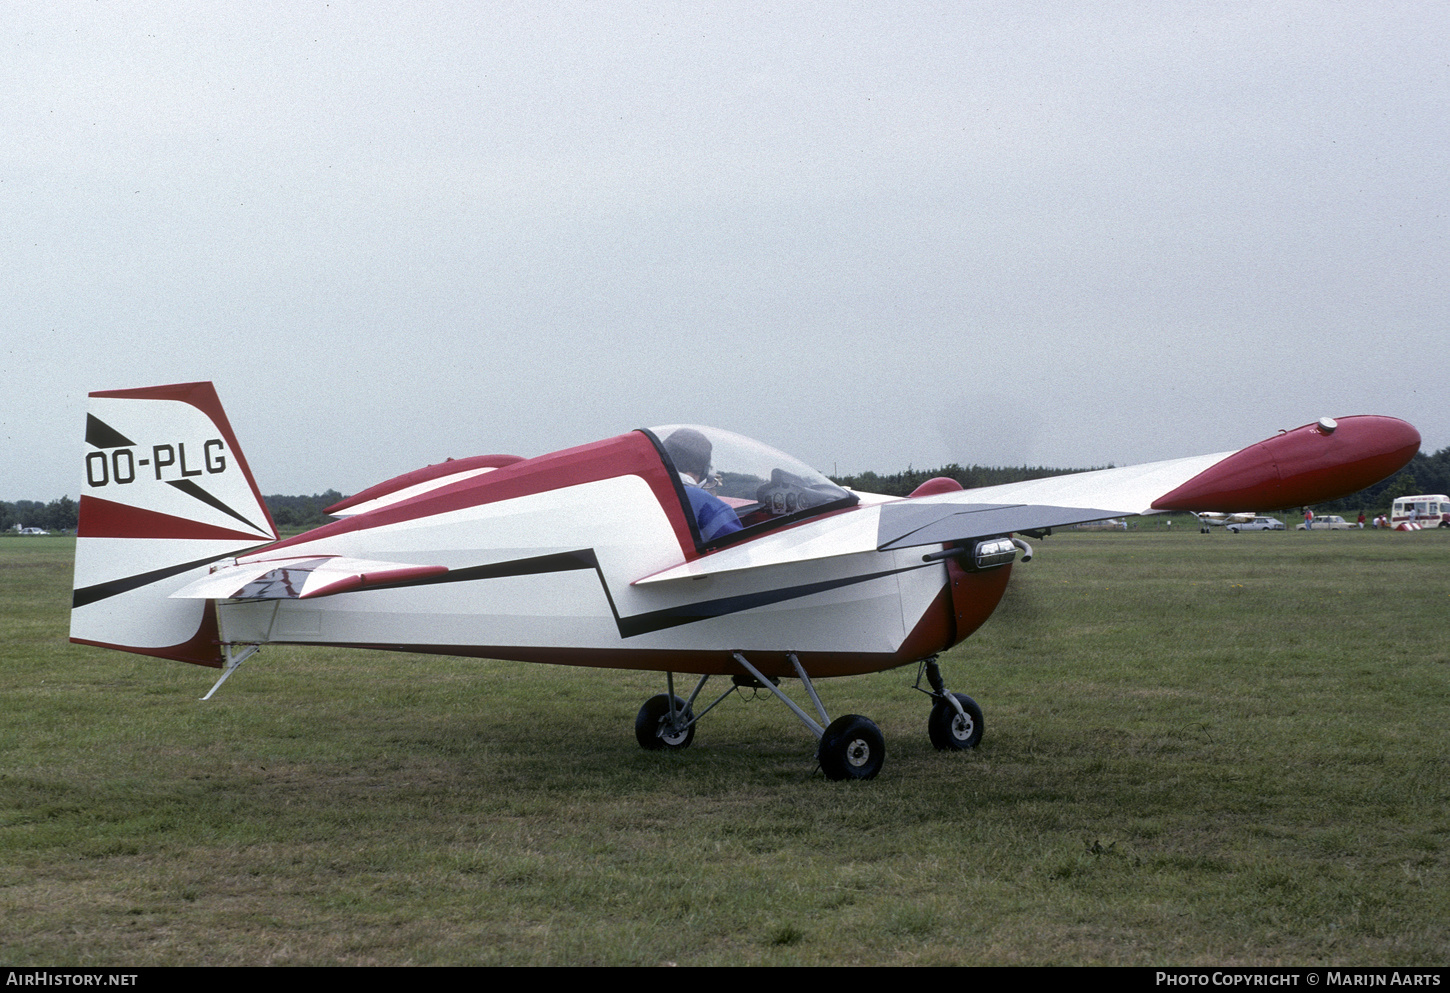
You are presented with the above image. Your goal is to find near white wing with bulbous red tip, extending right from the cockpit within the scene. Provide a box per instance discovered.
[635,415,1420,586]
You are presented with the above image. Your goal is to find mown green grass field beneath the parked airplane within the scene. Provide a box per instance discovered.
[0,529,1450,965]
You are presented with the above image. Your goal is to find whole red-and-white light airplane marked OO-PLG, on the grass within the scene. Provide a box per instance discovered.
[71,383,1420,778]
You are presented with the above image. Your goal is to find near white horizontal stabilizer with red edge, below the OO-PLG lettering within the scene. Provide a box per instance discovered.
[171,555,448,600]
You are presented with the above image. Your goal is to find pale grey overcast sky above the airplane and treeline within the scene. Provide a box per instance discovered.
[0,0,1450,500]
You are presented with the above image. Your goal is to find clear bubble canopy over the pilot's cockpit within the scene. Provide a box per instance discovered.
[644,425,858,548]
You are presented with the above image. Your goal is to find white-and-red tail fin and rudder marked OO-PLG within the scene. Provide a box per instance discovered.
[71,383,277,667]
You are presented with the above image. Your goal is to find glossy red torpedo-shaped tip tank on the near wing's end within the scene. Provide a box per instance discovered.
[1153,415,1420,512]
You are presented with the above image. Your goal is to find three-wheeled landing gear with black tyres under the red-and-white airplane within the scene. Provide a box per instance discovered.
[635,652,982,780]
